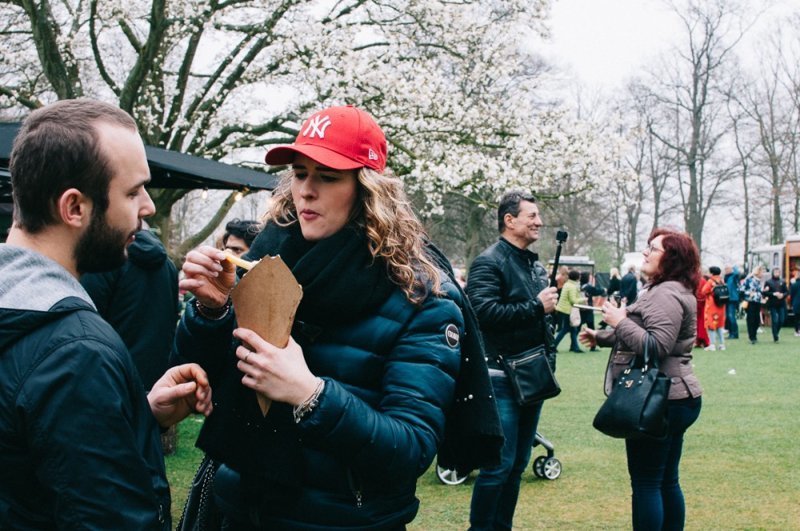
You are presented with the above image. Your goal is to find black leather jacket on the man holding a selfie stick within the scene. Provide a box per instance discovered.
[467,238,548,369]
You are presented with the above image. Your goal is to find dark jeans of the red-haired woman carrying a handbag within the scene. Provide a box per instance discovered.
[625,397,702,531]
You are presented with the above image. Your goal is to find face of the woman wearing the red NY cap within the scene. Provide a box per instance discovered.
[291,153,358,241]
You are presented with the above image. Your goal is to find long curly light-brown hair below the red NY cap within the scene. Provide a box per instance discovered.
[264,168,442,304]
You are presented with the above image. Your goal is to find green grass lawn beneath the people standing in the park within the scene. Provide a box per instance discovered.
[167,323,800,530]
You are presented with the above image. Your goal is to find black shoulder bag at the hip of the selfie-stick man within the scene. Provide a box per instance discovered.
[500,344,561,406]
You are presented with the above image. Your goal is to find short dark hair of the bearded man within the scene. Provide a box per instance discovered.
[9,99,137,234]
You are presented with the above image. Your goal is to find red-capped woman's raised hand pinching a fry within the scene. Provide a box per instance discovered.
[178,245,236,308]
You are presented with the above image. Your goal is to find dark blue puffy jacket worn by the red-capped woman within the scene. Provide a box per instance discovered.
[174,281,464,530]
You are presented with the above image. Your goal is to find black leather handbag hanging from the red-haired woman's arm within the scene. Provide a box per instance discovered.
[592,337,670,439]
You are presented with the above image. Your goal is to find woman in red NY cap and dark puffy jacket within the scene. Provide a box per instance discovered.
[176,107,464,529]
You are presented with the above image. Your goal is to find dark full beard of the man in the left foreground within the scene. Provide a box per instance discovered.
[75,213,136,275]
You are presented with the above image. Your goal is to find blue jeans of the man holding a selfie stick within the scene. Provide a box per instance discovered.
[469,375,542,531]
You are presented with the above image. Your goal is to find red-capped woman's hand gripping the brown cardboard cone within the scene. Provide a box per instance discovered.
[233,328,319,406]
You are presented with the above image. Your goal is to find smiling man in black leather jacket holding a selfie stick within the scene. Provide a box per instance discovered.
[467,191,560,531]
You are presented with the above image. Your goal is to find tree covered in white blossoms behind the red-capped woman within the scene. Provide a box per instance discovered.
[0,0,616,257]
